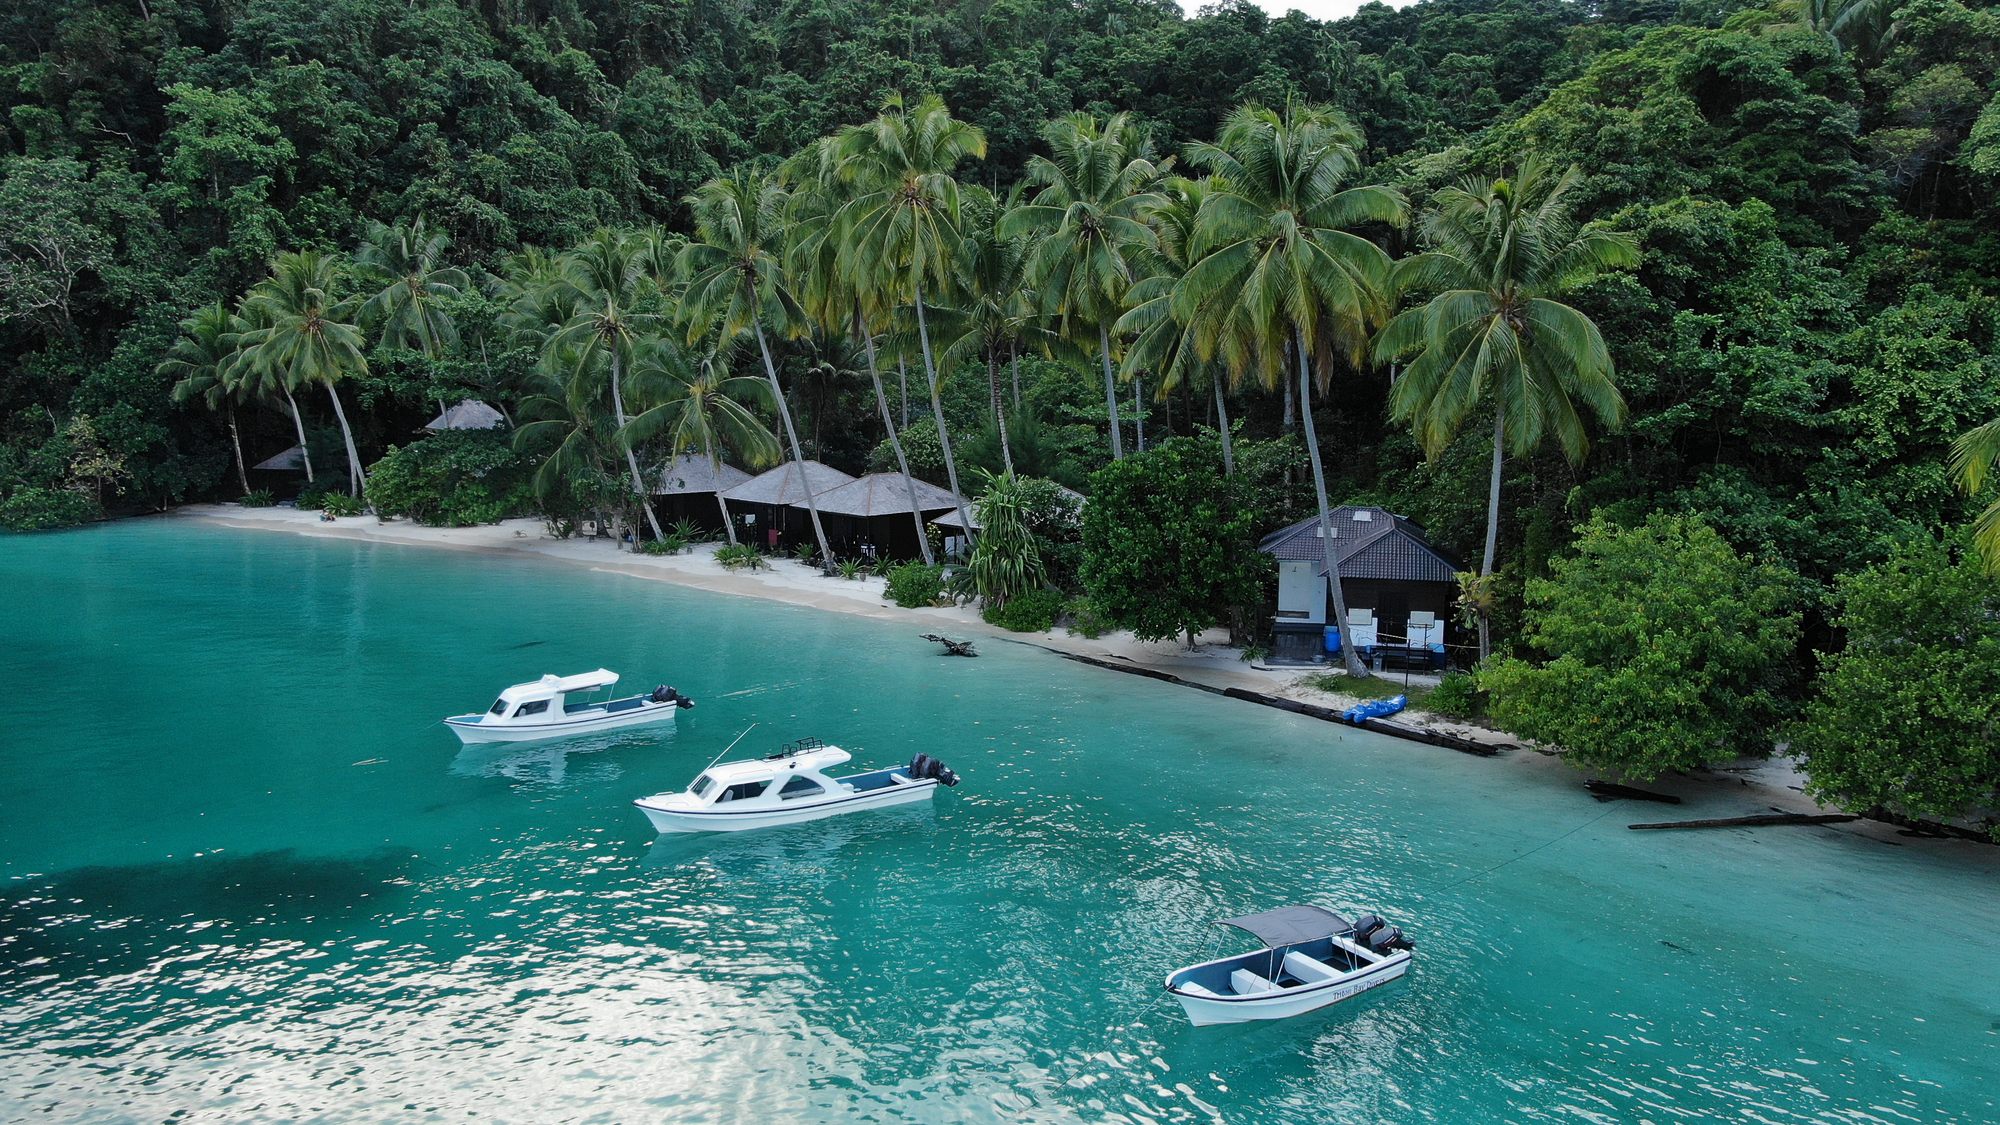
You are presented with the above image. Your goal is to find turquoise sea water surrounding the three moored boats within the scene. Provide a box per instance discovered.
[0,520,2000,1125]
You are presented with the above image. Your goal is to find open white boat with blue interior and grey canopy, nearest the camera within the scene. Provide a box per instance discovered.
[1166,907,1412,1027]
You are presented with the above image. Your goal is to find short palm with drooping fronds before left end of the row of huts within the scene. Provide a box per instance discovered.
[620,340,778,544]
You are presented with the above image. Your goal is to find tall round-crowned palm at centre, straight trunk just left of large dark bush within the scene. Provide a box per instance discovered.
[1002,114,1166,460]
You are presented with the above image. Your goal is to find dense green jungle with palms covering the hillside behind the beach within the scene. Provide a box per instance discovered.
[0,0,2000,819]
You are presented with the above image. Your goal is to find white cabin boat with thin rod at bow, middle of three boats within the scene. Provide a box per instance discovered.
[634,739,958,833]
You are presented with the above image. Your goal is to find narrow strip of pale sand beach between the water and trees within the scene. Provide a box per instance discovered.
[176,504,2000,856]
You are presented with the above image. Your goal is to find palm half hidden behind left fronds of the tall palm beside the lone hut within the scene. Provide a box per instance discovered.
[1112,176,1236,472]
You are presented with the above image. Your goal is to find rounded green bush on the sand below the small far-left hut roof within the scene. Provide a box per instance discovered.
[368,430,530,526]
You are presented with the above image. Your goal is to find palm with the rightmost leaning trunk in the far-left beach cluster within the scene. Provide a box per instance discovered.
[244,250,368,496]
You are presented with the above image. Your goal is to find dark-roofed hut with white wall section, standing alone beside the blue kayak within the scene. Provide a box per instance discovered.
[1258,504,1462,667]
